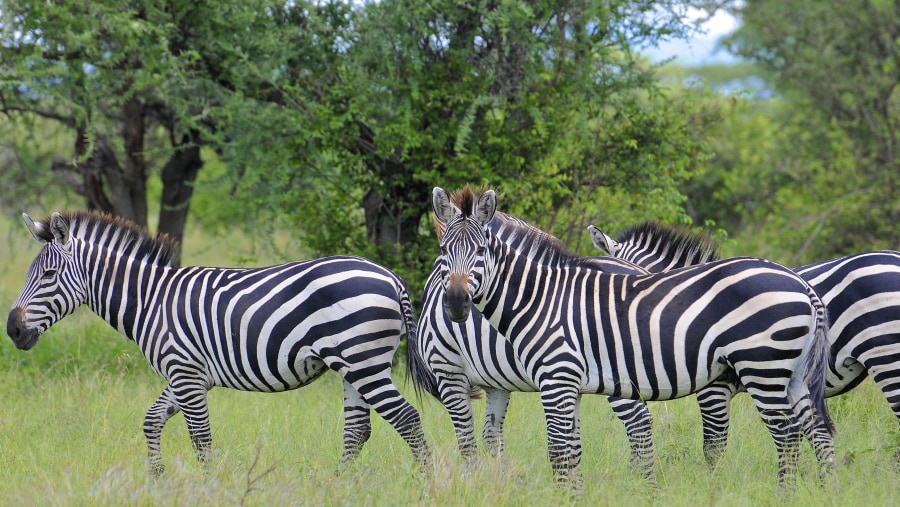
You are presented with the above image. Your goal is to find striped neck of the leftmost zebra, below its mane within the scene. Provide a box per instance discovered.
[80,243,173,341]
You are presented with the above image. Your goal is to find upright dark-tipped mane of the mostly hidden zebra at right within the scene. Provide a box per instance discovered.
[619,220,721,264]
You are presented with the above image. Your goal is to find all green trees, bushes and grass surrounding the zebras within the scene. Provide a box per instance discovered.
[0,0,900,505]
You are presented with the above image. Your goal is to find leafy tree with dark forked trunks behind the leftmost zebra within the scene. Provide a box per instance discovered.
[0,0,298,266]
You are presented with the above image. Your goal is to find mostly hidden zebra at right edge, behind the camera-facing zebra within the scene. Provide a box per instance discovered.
[589,223,900,466]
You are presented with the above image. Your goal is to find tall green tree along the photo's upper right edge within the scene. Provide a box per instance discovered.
[726,0,900,255]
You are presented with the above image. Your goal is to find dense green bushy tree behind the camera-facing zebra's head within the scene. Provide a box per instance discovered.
[232,0,714,290]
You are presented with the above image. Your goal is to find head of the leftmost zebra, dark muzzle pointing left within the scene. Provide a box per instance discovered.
[6,213,87,350]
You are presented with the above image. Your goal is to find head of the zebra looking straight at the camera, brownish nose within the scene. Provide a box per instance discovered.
[432,186,497,322]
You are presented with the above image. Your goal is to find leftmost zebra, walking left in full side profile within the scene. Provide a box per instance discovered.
[7,211,430,475]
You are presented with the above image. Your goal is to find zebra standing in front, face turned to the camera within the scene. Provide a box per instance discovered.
[432,187,833,488]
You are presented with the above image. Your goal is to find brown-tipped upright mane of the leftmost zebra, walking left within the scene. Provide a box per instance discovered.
[37,210,178,266]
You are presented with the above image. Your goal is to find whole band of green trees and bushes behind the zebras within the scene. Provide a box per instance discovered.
[0,0,900,293]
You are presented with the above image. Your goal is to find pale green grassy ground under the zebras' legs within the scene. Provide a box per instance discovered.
[0,212,900,506]
